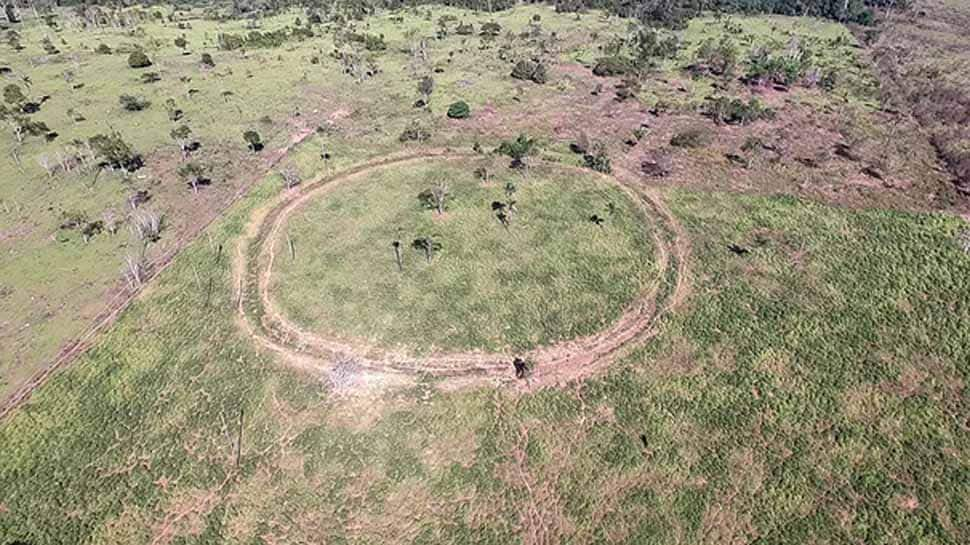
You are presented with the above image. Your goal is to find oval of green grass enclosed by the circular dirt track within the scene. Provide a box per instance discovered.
[270,160,656,352]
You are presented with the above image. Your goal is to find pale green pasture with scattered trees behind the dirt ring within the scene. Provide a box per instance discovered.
[0,0,892,395]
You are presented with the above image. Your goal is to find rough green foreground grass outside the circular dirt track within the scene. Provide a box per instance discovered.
[0,184,970,544]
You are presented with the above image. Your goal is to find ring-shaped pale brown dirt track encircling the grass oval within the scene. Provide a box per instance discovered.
[232,149,689,390]
